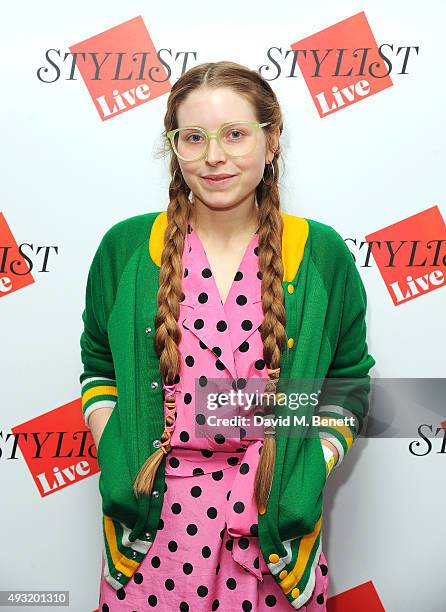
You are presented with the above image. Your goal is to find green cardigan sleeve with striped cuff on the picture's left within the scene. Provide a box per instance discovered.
[79,241,117,427]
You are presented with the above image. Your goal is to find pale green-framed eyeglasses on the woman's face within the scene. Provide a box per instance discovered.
[167,121,271,161]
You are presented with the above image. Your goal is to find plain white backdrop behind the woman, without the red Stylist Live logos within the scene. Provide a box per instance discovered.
[0,0,446,612]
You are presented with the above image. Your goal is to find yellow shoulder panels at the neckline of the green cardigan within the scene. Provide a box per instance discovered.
[149,211,309,283]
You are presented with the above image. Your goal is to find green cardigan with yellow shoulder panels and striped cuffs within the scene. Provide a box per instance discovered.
[79,211,375,608]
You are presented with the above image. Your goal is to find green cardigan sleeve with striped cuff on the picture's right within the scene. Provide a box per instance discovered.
[317,249,376,466]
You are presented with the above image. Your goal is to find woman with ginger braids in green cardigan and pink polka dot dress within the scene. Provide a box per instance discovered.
[80,62,375,612]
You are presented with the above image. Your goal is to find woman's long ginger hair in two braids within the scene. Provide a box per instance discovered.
[134,61,286,513]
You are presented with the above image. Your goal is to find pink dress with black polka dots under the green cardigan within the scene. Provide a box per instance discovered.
[99,225,329,612]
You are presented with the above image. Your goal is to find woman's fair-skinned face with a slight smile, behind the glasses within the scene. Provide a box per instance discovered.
[177,87,277,209]
